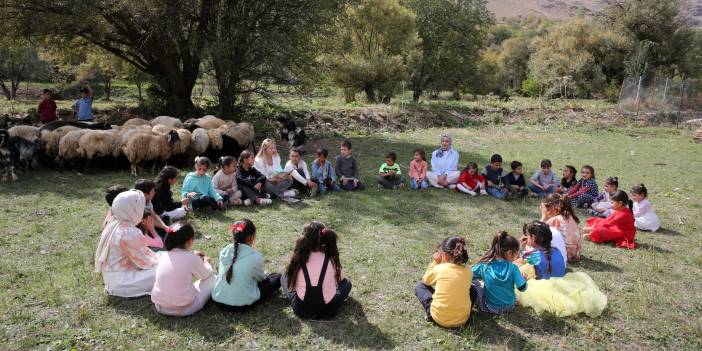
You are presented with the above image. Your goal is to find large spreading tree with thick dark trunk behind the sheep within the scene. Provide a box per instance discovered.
[0,0,216,114]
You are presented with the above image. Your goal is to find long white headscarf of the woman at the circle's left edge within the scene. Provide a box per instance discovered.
[95,190,146,272]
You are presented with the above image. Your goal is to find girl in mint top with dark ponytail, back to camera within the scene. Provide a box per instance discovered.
[212,218,281,312]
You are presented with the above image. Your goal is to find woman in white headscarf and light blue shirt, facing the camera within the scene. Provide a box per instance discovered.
[427,134,461,189]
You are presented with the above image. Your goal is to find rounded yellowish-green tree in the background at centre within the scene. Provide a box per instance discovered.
[328,0,418,103]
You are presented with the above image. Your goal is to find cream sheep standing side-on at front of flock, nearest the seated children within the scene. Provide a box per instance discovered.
[122,131,179,177]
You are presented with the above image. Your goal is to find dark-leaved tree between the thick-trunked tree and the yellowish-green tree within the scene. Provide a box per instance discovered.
[208,0,342,116]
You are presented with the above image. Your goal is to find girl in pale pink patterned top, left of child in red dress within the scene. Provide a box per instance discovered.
[541,194,582,262]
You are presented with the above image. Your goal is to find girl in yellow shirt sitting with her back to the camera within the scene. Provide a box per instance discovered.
[414,237,473,328]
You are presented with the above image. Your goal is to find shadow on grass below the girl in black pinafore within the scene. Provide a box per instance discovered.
[304,297,395,350]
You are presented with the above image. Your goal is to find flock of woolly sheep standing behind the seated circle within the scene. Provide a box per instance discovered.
[0,116,255,176]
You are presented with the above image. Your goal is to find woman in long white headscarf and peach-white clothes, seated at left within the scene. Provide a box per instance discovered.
[95,190,159,297]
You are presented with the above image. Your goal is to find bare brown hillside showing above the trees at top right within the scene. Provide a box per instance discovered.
[488,0,702,26]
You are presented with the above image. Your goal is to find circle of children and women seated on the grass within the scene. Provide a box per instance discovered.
[95,136,660,327]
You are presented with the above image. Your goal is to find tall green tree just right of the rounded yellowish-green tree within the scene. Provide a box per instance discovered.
[406,0,496,102]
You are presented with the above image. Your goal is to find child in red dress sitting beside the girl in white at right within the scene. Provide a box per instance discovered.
[583,190,636,249]
